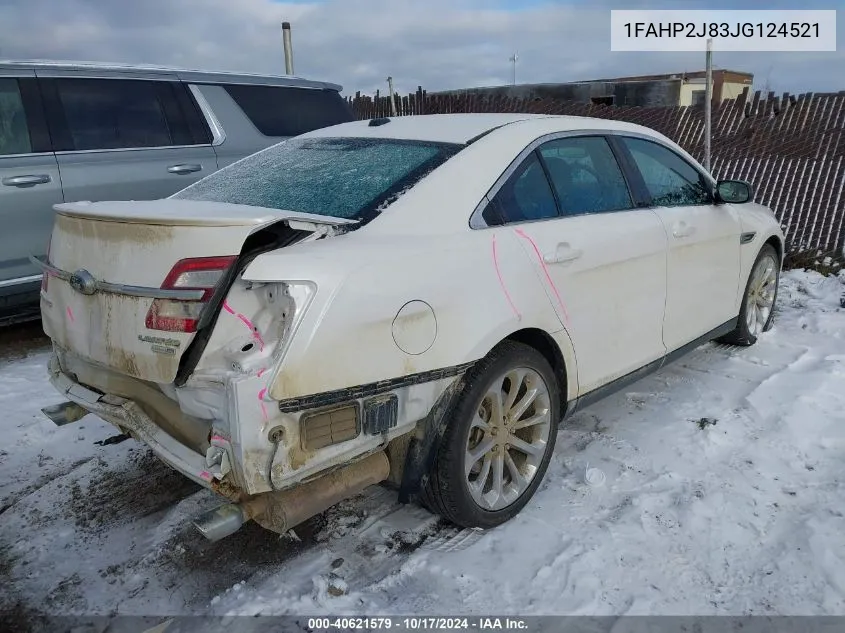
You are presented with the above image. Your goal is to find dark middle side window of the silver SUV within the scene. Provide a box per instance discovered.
[55,79,179,150]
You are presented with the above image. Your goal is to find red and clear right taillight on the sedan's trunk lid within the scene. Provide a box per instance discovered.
[145,255,237,332]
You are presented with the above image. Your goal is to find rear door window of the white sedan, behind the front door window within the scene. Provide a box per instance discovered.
[540,136,632,215]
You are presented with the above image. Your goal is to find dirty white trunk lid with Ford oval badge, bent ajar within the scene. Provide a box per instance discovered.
[41,199,352,383]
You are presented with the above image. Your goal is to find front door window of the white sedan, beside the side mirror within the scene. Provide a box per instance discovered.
[623,138,712,207]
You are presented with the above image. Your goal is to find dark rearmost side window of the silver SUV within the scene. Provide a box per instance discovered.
[223,85,354,136]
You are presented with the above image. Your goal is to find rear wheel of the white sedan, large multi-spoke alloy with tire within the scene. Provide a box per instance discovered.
[421,341,561,529]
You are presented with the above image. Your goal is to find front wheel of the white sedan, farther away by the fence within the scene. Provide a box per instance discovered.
[718,244,780,346]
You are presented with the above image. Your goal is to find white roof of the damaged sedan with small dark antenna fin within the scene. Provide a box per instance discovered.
[304,113,662,145]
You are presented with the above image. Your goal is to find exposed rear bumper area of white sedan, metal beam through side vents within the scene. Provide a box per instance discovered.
[49,347,465,501]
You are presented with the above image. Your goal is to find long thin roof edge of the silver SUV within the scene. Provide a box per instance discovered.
[0,59,343,92]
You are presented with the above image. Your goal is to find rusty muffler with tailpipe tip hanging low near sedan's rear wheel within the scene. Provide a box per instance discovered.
[194,451,390,541]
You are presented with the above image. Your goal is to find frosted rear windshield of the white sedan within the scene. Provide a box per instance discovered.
[172,138,461,221]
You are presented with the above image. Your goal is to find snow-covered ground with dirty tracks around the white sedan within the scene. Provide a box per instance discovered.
[0,271,845,618]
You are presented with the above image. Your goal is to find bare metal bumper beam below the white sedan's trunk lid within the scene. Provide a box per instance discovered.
[48,355,220,492]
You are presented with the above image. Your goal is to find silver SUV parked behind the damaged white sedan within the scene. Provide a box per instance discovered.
[0,62,353,324]
